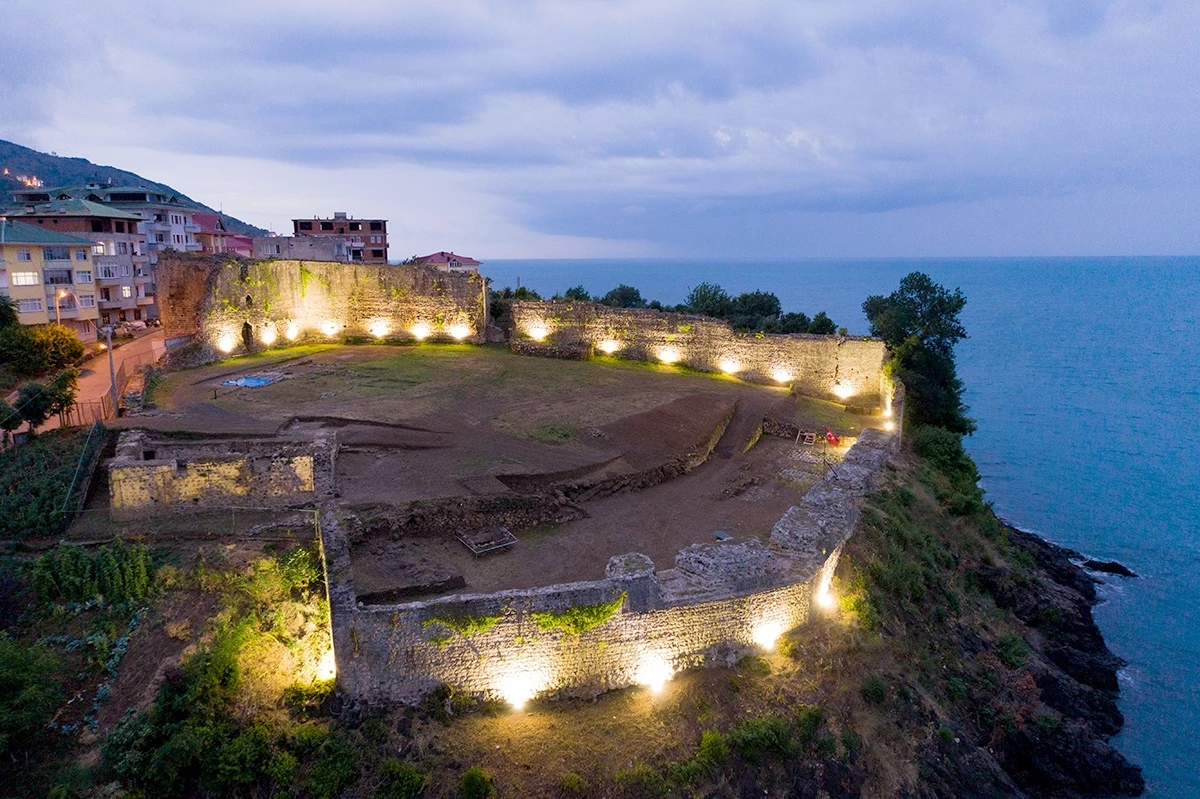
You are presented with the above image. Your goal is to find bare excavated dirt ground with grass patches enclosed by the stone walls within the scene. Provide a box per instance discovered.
[125,346,871,597]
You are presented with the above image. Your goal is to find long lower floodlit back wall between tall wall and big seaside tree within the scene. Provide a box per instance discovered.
[512,301,890,408]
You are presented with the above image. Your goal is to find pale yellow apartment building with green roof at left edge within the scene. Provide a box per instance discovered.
[0,216,98,344]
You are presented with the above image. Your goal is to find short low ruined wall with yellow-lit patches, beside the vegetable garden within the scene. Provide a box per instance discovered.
[108,431,336,519]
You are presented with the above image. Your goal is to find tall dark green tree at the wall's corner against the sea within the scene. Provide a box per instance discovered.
[863,272,976,434]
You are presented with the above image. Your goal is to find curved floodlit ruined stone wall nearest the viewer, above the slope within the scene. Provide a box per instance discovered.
[320,429,898,703]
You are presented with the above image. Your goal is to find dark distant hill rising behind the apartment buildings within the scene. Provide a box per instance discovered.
[0,139,266,236]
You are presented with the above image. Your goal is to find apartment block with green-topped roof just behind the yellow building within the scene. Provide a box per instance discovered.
[8,199,155,325]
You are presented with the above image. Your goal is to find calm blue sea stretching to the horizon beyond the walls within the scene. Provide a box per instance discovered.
[484,258,1200,799]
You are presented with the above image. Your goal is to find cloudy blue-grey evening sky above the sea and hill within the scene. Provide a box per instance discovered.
[0,0,1200,258]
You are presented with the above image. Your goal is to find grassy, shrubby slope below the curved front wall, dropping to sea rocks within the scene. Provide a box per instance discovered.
[4,427,1140,797]
